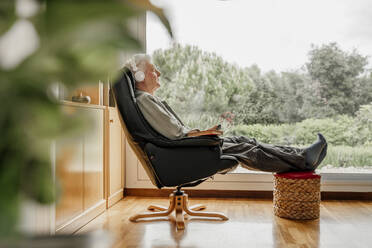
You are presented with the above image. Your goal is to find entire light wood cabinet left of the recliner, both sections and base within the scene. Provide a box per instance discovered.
[55,102,126,233]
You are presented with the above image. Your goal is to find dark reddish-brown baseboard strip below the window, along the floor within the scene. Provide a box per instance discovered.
[124,188,372,201]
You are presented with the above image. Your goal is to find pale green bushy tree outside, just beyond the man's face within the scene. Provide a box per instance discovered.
[153,44,253,128]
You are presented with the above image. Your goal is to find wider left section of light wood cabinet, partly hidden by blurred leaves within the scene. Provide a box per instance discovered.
[55,104,106,233]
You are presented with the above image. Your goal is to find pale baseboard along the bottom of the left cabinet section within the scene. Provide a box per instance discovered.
[56,200,106,234]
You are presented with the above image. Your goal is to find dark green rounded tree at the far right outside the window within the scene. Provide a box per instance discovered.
[306,43,368,116]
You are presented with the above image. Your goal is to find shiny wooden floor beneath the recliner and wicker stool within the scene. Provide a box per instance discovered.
[78,197,372,248]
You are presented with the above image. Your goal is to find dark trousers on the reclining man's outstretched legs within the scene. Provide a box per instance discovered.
[222,136,306,172]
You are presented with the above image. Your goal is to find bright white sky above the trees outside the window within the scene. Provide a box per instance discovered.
[146,0,372,72]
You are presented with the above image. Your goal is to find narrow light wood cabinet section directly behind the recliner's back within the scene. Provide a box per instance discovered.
[105,107,125,208]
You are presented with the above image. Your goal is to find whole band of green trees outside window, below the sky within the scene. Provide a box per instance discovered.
[153,43,372,127]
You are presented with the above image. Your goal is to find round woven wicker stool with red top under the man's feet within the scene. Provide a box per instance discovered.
[274,172,320,220]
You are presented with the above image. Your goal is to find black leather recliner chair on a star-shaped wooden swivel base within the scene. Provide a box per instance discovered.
[112,68,238,229]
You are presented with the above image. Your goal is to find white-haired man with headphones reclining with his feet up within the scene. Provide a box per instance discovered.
[128,54,327,172]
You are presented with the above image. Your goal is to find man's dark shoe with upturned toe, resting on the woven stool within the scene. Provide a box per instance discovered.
[305,133,327,169]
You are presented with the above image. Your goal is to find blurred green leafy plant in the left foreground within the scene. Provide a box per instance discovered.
[0,0,172,238]
